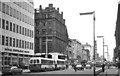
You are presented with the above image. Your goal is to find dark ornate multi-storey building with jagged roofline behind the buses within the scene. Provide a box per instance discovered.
[35,4,68,54]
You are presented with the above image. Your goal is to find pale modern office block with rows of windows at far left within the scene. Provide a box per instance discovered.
[0,0,34,69]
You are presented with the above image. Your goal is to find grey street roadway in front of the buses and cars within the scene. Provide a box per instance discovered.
[2,68,101,76]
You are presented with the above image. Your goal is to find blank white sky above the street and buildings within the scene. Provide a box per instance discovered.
[34,0,119,59]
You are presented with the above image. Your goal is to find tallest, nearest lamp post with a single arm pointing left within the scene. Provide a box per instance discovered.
[80,11,96,76]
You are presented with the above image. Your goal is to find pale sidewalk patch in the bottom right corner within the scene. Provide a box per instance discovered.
[97,68,118,76]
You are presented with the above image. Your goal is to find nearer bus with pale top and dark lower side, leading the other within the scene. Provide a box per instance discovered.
[29,57,55,72]
